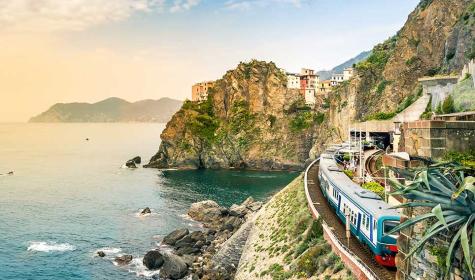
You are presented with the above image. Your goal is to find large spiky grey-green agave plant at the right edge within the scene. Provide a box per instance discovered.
[389,163,475,278]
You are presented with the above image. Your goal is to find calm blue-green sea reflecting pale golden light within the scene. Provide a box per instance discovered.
[0,124,297,280]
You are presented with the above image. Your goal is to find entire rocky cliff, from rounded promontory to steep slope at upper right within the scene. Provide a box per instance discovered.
[149,0,475,169]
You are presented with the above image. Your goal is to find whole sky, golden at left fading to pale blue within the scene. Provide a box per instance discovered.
[0,0,418,122]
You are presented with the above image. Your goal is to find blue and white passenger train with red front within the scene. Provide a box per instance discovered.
[318,153,401,267]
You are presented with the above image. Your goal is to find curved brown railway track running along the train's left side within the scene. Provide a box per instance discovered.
[307,164,396,280]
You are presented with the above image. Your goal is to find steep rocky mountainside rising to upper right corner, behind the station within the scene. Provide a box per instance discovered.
[311,0,475,157]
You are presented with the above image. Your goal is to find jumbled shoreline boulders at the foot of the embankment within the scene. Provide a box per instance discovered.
[139,197,263,280]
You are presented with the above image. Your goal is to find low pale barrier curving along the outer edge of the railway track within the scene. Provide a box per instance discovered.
[304,158,380,280]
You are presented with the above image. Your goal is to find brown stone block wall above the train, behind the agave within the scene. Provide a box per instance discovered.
[403,120,475,160]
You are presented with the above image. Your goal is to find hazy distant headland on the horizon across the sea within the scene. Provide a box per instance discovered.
[29,97,183,123]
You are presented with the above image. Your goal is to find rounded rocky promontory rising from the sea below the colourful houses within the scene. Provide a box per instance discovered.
[148,60,324,170]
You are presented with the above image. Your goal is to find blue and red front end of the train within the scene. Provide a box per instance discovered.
[375,216,400,267]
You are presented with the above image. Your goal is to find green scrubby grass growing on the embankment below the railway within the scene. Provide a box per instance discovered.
[247,177,352,280]
